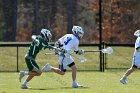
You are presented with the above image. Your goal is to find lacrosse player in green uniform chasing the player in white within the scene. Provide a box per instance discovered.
[19,29,52,89]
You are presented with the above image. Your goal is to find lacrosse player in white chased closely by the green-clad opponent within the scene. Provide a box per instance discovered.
[44,26,84,88]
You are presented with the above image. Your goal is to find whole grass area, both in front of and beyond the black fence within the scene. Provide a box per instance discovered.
[0,43,140,93]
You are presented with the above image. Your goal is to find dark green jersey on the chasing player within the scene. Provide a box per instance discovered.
[27,35,48,58]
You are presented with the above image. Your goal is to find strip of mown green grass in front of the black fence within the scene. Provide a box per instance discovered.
[0,71,140,93]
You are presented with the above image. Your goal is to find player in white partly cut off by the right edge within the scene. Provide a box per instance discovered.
[120,30,140,84]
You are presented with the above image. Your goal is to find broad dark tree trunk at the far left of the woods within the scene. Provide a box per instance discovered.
[2,0,17,41]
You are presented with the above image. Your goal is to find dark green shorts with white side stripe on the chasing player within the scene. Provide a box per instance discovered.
[25,57,39,71]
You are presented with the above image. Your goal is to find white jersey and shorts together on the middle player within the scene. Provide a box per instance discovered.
[58,34,79,69]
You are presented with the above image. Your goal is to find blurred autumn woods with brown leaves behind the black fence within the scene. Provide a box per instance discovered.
[0,0,140,43]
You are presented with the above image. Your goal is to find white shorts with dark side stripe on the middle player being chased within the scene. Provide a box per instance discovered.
[58,55,74,69]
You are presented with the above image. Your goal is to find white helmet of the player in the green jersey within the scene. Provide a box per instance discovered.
[40,29,52,42]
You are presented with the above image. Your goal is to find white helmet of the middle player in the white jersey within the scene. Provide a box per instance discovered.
[72,26,84,39]
